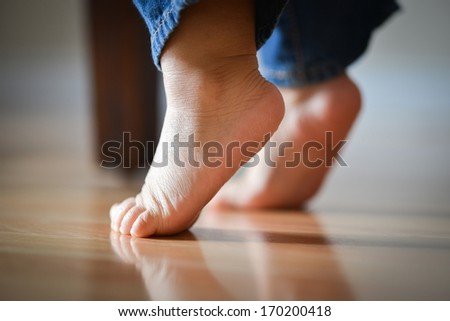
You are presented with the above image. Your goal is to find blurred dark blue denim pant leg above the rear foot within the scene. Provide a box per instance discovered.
[258,0,399,86]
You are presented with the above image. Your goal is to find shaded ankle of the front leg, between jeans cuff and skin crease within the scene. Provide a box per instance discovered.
[161,0,256,72]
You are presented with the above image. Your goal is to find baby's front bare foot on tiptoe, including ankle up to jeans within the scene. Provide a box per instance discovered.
[110,0,283,237]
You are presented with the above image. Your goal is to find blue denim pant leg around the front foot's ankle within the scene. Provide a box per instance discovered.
[133,0,288,70]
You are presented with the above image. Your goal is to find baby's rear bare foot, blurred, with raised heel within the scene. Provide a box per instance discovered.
[211,75,361,209]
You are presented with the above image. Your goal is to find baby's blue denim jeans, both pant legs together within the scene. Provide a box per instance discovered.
[134,0,399,86]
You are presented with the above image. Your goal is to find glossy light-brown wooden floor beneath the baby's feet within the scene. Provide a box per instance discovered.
[0,113,450,300]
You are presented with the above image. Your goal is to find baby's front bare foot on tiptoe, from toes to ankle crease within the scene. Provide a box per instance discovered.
[111,65,282,237]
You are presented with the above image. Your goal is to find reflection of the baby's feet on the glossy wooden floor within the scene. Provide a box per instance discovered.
[111,212,352,300]
